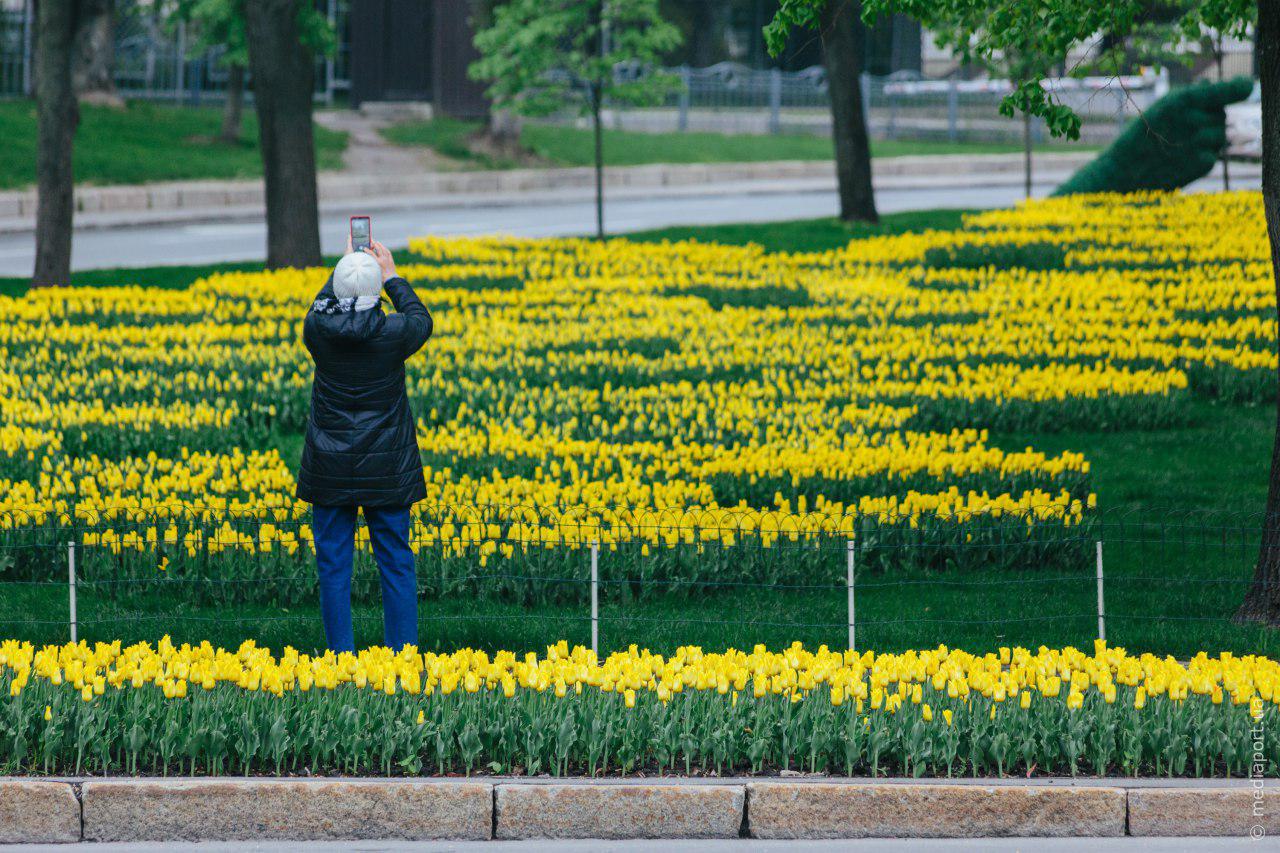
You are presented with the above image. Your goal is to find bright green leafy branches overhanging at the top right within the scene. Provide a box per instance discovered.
[764,0,1257,140]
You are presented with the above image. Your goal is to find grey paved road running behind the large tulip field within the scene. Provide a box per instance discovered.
[0,167,1257,270]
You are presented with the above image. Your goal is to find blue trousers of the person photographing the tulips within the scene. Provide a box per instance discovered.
[311,506,417,652]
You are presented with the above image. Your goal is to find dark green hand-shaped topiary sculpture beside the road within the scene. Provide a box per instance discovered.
[1053,77,1253,196]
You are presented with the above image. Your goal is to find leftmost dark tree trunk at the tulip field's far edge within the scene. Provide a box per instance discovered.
[31,0,79,287]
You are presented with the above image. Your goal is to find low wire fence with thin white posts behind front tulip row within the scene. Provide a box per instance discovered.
[0,507,1280,657]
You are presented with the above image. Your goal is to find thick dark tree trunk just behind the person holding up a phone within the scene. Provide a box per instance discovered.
[244,0,320,269]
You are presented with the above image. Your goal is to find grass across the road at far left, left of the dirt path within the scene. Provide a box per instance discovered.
[0,100,347,188]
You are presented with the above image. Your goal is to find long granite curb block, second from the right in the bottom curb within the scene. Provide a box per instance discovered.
[746,783,1125,839]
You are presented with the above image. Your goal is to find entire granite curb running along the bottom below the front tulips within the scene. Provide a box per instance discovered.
[0,777,1264,844]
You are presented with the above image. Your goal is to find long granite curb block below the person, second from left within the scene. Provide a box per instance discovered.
[81,780,493,841]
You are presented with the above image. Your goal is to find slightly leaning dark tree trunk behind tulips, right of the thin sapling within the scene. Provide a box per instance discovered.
[820,0,879,222]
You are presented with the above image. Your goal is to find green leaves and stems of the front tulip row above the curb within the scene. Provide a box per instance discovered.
[0,662,1280,781]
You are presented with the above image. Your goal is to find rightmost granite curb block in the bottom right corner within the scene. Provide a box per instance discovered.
[1129,779,1280,838]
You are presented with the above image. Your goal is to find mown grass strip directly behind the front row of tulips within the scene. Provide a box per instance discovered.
[0,555,1280,658]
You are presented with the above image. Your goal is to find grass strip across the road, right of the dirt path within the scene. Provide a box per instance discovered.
[383,118,1089,169]
